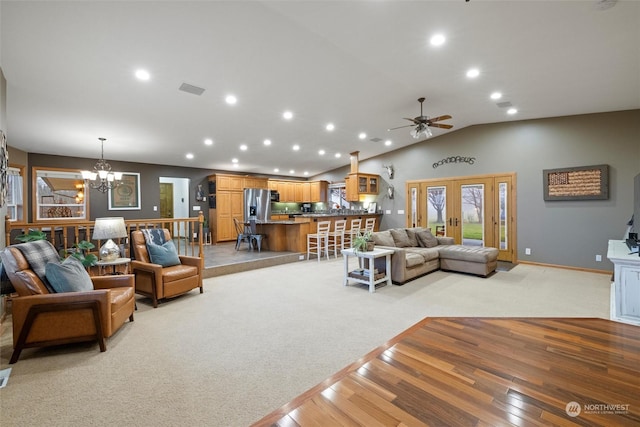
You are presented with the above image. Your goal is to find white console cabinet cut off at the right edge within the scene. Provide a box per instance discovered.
[607,240,640,325]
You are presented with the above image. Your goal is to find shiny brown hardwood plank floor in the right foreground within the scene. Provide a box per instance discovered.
[254,318,640,427]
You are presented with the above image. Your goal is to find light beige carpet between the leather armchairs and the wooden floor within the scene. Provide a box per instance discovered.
[0,259,610,427]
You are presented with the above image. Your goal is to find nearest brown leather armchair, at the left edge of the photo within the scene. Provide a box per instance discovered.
[0,243,135,363]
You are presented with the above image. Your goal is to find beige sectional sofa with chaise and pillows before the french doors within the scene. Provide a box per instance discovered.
[373,227,498,284]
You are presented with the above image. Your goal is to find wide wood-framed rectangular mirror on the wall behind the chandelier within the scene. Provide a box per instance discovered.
[32,167,89,221]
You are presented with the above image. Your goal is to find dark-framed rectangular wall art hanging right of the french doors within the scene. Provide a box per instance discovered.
[542,165,609,201]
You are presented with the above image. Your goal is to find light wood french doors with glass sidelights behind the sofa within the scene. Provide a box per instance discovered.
[407,174,516,262]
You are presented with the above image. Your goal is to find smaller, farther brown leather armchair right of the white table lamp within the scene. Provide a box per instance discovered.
[131,228,204,308]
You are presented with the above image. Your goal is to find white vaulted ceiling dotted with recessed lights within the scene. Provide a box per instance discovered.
[0,0,640,177]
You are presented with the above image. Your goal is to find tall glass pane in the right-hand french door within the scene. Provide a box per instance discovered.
[460,184,484,246]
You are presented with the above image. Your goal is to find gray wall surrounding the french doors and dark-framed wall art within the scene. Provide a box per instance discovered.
[312,110,640,270]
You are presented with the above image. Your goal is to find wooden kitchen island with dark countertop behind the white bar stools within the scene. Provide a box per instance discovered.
[256,213,382,253]
